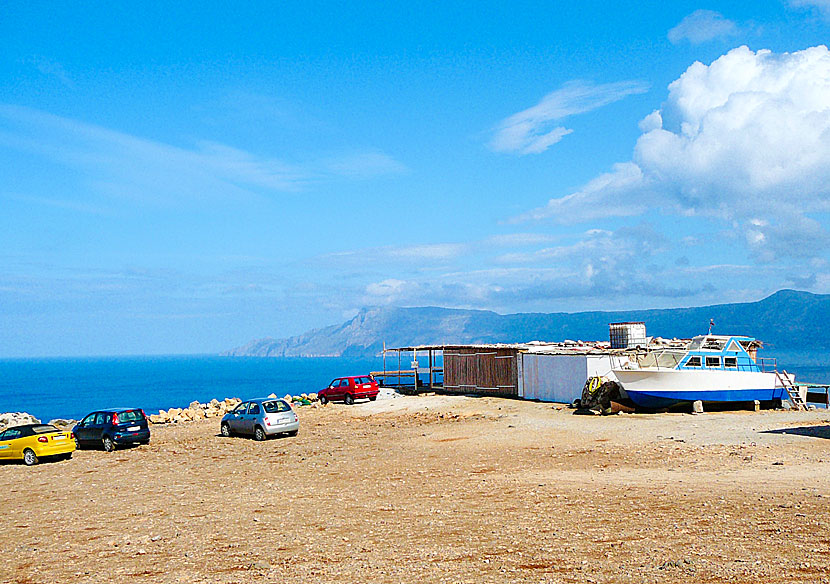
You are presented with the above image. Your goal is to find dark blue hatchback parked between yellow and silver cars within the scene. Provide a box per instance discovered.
[72,408,150,452]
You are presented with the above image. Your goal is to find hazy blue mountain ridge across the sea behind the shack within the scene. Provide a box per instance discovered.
[223,290,830,357]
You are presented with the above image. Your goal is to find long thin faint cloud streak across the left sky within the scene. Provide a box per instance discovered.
[0,104,403,201]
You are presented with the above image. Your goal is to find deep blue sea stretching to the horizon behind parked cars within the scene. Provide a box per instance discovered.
[0,354,830,421]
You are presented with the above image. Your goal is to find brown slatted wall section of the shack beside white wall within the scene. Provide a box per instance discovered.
[444,348,519,397]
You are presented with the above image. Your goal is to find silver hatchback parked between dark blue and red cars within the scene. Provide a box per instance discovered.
[220,397,300,440]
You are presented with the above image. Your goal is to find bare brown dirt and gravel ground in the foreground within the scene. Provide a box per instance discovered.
[0,396,830,584]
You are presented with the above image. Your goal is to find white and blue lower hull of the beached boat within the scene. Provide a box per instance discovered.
[614,369,785,409]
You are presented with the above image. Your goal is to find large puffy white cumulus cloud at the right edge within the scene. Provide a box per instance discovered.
[521,46,830,257]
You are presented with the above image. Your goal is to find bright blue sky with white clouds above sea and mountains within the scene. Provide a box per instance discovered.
[0,0,830,357]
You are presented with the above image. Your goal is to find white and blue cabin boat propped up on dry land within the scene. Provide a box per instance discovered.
[613,335,786,409]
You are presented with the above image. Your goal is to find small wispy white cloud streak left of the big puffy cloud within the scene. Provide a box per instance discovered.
[489,81,648,154]
